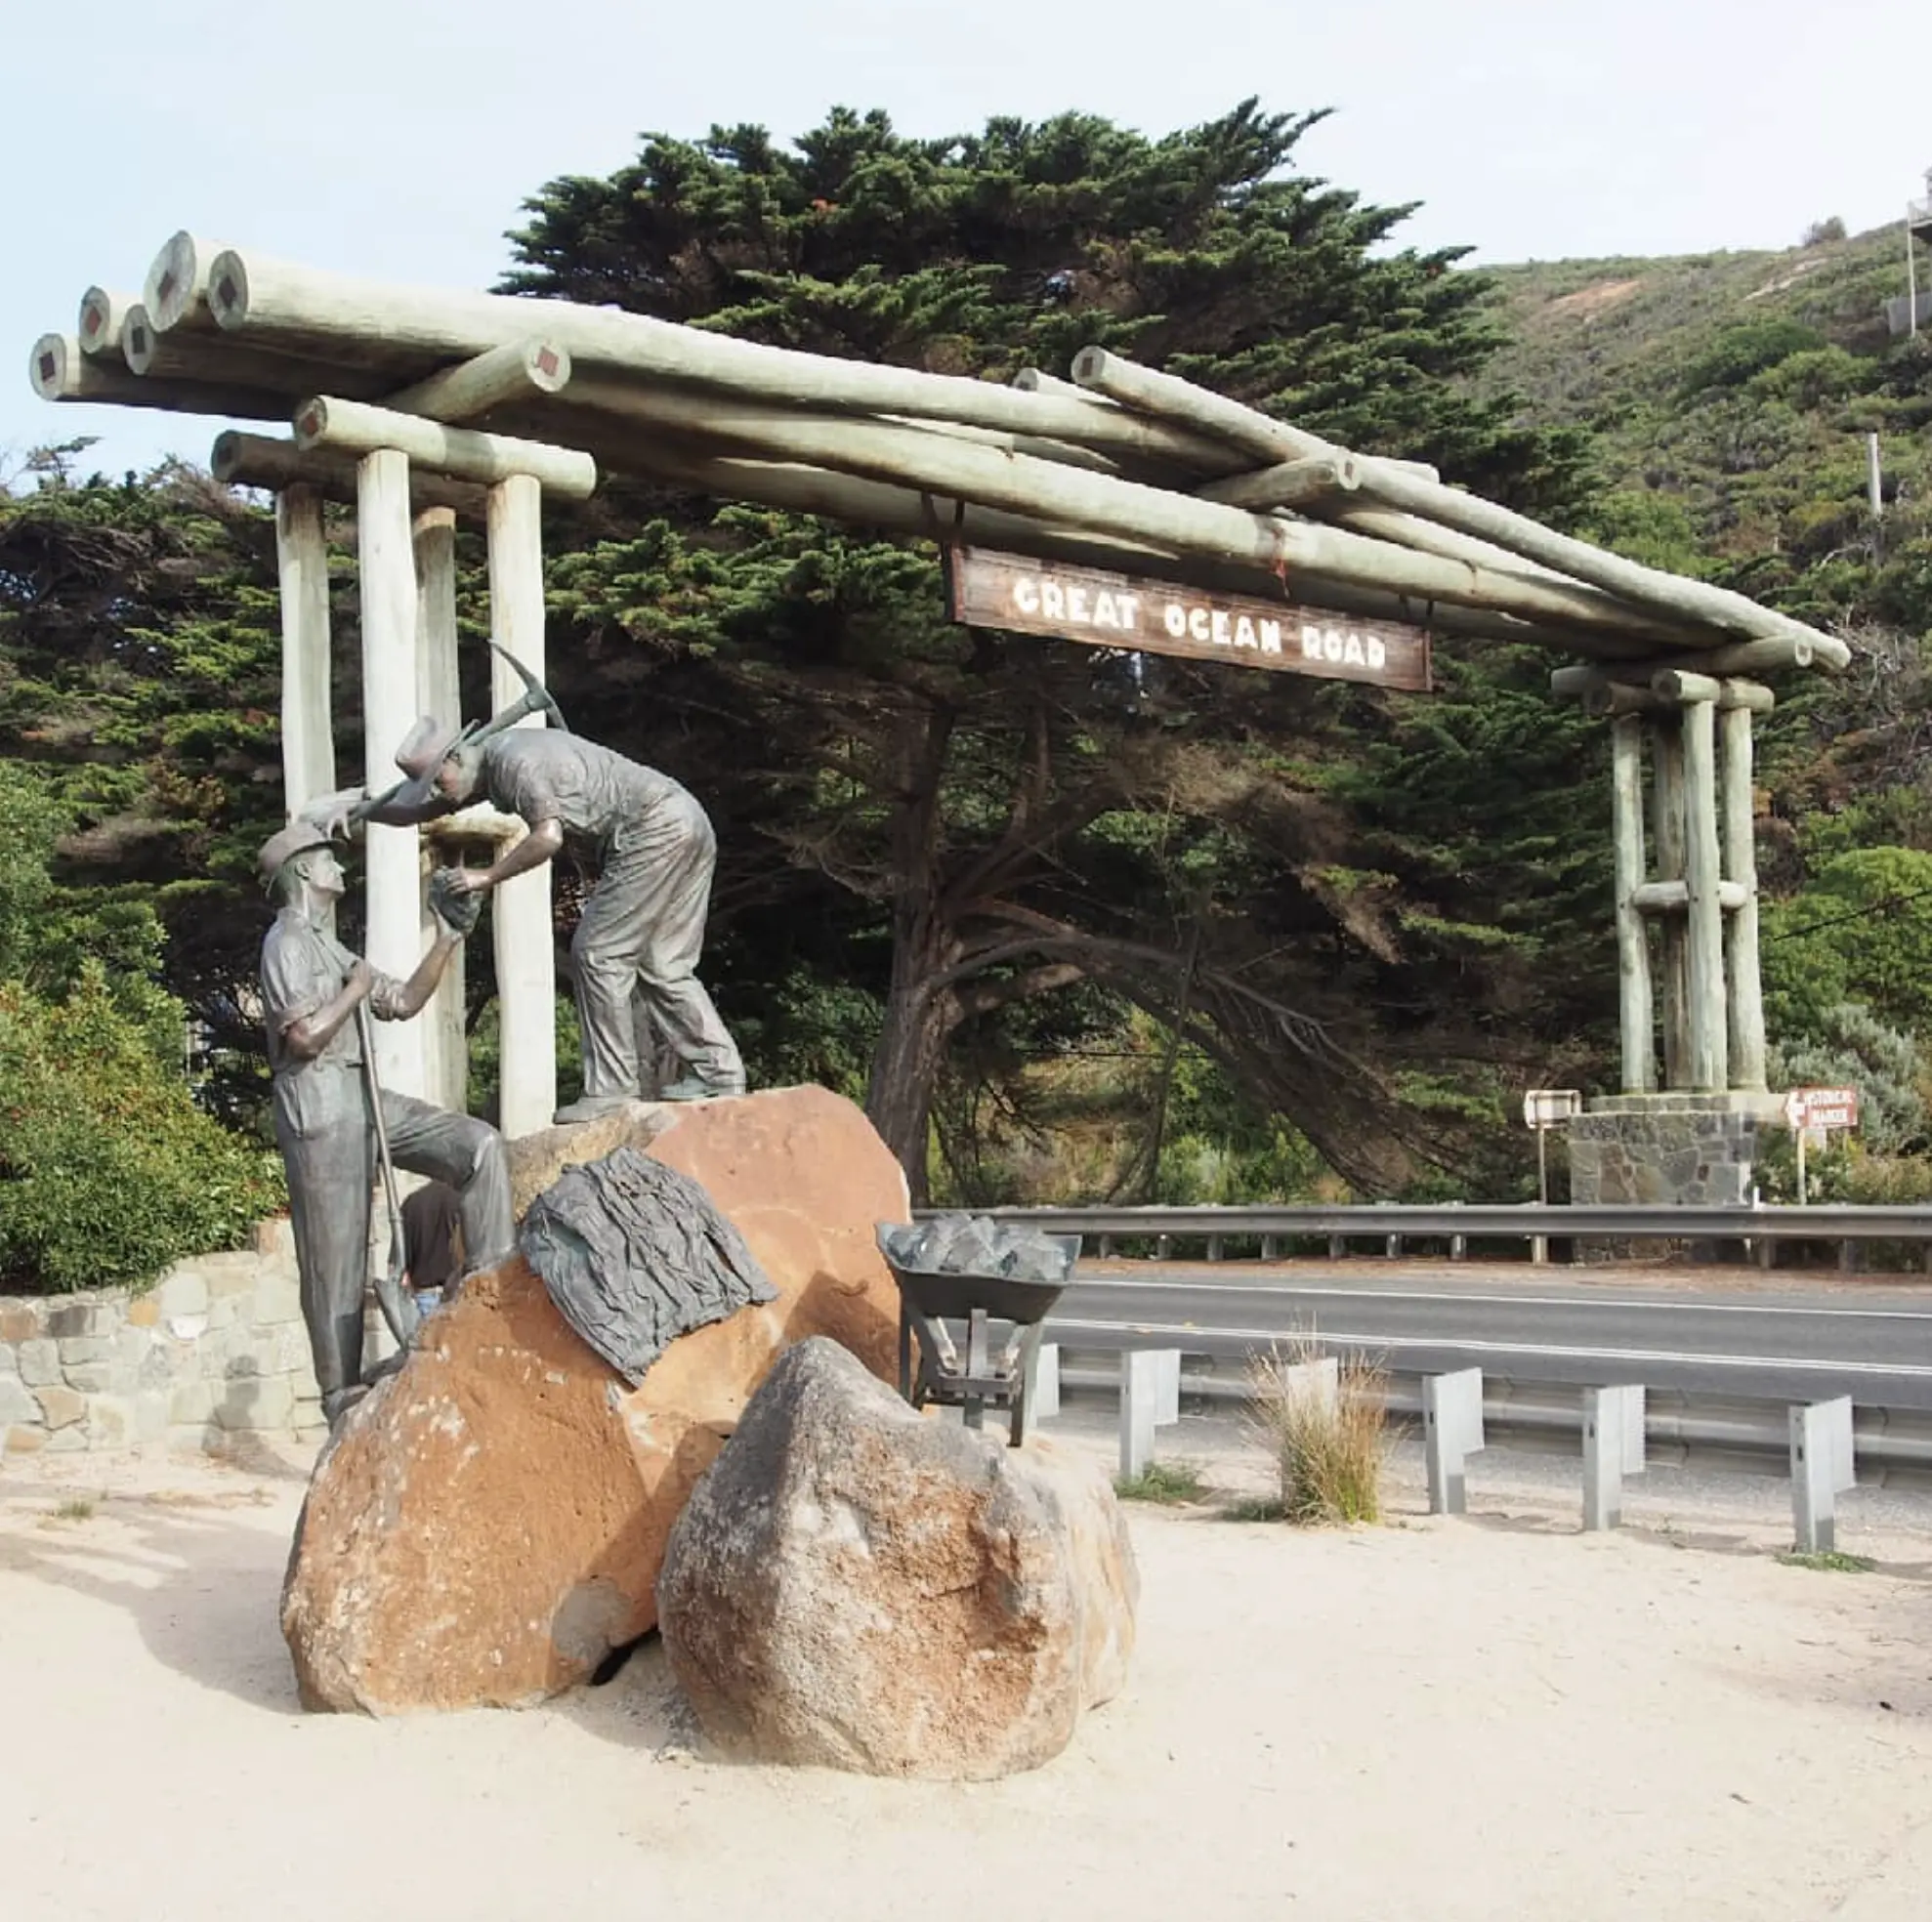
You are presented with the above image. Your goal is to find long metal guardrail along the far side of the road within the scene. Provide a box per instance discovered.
[918,1201,1932,1244]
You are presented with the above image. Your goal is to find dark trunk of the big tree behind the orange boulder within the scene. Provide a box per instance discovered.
[865,707,962,1207]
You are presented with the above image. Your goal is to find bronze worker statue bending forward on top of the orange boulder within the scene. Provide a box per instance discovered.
[320,715,744,1122]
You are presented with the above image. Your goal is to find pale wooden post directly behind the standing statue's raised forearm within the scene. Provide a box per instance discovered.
[356,448,423,1095]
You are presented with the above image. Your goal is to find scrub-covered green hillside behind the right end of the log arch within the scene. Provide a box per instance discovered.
[1460,226,1932,1197]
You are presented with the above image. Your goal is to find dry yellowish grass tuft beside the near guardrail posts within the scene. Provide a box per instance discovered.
[1248,1337,1395,1526]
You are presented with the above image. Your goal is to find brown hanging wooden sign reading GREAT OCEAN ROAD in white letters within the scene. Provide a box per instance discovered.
[948,547,1430,693]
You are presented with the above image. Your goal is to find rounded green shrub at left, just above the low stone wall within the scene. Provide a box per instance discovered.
[0,960,282,1294]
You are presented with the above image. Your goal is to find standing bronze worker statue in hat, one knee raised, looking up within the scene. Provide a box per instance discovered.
[257,819,516,1428]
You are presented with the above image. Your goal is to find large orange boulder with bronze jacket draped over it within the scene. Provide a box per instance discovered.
[282,1088,906,1715]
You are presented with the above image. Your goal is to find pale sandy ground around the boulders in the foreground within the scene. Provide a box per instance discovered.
[0,1410,1932,1922]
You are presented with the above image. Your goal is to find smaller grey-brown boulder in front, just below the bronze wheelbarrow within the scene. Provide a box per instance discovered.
[657,1341,1140,1779]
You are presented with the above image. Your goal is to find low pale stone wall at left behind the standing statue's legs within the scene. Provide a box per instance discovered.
[0,1219,326,1454]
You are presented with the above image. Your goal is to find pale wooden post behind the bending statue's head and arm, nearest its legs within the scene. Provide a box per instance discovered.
[488,474,557,1140]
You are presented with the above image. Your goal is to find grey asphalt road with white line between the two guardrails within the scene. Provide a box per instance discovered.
[1049,1264,1932,1410]
